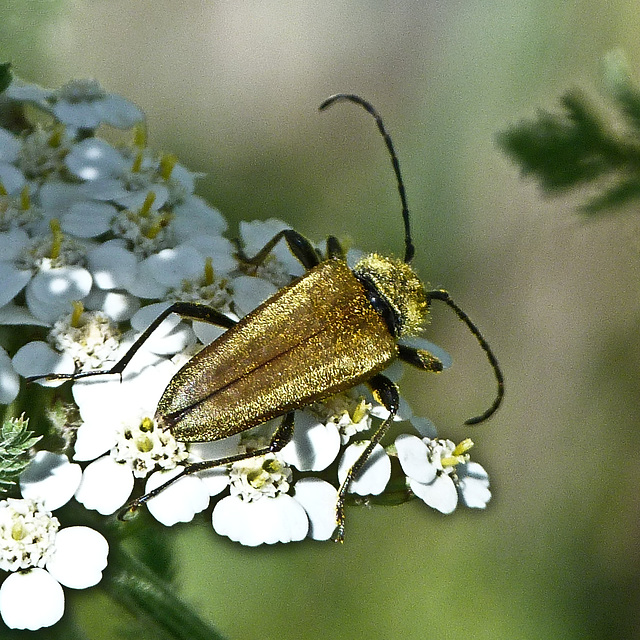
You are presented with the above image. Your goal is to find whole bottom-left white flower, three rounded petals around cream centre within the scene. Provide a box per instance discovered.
[0,451,109,630]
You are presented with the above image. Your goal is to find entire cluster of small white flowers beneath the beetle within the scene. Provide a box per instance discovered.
[0,76,490,626]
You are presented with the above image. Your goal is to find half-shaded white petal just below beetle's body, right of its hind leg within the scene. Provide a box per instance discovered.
[280,411,340,471]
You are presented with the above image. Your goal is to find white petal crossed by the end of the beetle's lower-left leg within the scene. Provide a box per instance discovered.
[144,467,209,527]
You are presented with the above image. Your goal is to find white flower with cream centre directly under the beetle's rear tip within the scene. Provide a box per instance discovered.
[73,354,209,526]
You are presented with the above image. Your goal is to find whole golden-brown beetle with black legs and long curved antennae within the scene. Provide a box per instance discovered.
[32,93,504,541]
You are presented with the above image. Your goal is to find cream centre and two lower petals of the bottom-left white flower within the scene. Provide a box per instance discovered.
[0,498,109,631]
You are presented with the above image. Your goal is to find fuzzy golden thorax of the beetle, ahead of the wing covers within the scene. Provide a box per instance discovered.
[353,253,429,336]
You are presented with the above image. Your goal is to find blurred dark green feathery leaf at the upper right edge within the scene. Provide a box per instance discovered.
[498,53,640,213]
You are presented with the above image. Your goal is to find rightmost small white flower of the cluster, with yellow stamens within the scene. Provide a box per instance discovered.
[395,434,491,513]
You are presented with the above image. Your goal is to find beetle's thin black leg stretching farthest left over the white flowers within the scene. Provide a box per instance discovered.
[27,302,237,382]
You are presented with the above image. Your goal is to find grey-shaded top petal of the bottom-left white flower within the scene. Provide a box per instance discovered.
[20,451,82,511]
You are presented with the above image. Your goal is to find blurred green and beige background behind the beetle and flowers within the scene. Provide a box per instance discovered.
[0,0,640,640]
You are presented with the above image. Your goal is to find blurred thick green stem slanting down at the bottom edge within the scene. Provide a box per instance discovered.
[101,548,225,640]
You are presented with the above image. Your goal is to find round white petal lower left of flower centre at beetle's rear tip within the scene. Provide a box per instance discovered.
[76,456,133,516]
